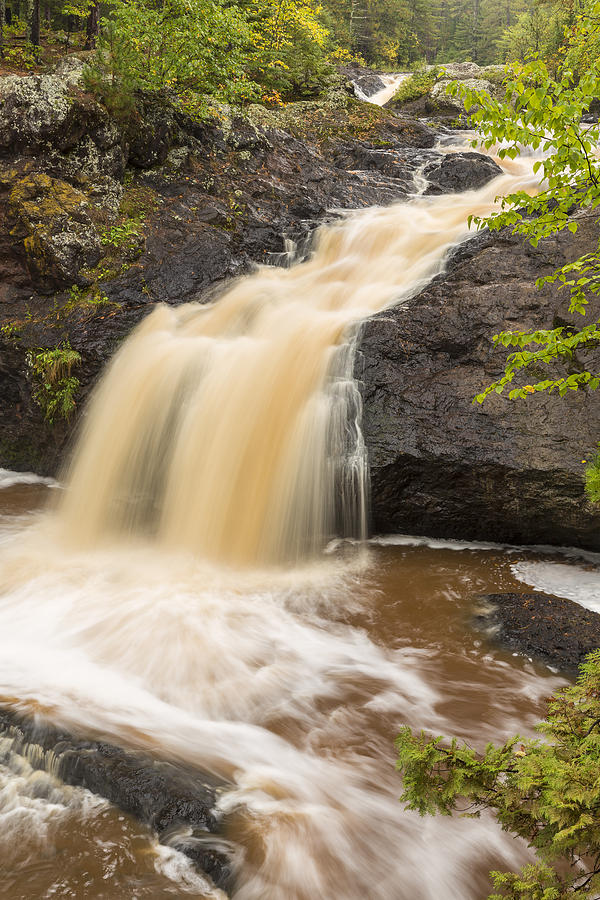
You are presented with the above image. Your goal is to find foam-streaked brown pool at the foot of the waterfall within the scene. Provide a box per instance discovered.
[0,485,568,900]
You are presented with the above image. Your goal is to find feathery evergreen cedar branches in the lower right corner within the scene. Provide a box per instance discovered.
[396,651,600,900]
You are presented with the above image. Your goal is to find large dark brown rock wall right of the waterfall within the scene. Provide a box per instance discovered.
[356,220,600,549]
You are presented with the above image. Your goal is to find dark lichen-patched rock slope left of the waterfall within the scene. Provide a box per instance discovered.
[0,67,435,473]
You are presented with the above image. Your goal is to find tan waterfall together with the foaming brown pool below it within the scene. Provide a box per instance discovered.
[0,142,580,900]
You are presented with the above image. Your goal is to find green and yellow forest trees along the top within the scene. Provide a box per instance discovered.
[0,0,581,102]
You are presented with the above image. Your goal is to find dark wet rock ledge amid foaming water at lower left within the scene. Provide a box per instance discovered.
[0,710,232,887]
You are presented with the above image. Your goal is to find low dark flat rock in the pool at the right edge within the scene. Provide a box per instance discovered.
[474,592,600,672]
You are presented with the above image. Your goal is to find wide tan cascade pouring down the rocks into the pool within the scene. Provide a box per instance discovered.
[54,150,532,566]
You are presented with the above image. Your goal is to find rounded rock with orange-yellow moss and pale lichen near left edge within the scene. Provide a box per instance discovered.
[8,173,102,289]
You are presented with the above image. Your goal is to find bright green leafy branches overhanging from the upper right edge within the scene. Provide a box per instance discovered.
[454,0,600,403]
